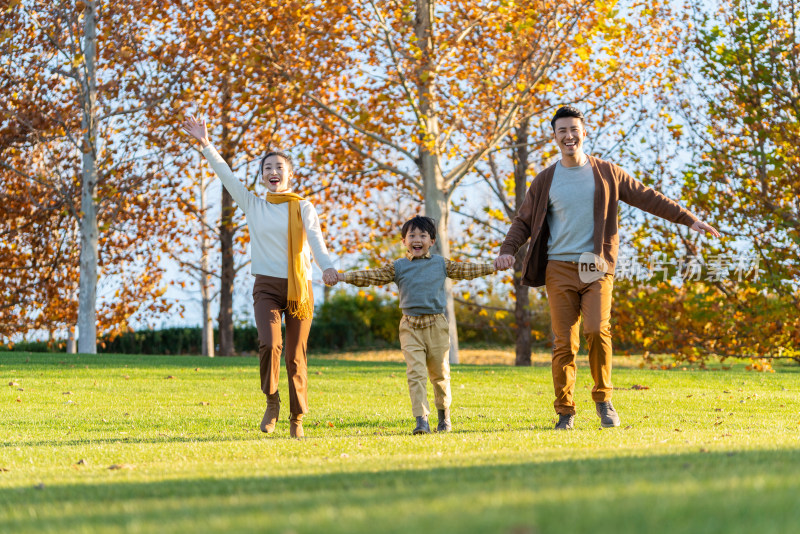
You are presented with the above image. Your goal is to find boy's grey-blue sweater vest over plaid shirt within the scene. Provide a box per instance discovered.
[394,254,447,316]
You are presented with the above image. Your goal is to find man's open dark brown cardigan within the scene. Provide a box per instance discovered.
[500,156,697,287]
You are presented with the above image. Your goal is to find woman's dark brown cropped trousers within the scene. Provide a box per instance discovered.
[253,274,313,414]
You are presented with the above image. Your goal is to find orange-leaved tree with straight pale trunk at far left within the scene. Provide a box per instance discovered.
[0,0,189,353]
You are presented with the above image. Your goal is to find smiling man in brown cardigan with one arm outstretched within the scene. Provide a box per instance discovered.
[494,106,719,430]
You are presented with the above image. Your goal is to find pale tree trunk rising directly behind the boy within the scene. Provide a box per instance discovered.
[414,0,458,364]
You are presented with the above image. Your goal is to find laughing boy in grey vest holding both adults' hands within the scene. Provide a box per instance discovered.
[339,216,495,434]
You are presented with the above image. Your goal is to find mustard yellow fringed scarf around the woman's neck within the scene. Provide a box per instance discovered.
[267,193,314,319]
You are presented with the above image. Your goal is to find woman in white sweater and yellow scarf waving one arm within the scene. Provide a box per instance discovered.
[182,117,338,438]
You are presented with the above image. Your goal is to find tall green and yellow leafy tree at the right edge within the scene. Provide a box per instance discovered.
[617,0,800,360]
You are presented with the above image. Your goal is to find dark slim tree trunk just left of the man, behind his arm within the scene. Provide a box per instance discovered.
[512,119,531,365]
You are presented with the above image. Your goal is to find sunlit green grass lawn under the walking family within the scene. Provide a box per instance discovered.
[0,353,800,534]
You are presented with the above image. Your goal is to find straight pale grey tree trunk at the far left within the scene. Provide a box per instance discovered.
[78,0,97,354]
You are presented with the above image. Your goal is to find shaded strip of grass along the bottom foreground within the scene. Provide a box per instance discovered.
[0,450,800,534]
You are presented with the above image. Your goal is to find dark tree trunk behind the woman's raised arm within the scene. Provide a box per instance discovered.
[217,77,236,356]
